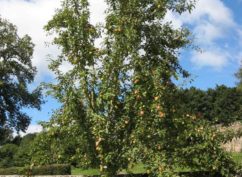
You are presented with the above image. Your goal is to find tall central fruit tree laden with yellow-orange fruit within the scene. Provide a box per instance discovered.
[36,0,238,177]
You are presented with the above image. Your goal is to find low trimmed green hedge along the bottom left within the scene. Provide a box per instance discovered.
[0,164,71,176]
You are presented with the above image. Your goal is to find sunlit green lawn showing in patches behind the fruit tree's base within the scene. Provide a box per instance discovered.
[72,152,242,176]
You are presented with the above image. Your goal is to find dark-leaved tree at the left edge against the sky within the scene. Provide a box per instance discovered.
[0,18,41,131]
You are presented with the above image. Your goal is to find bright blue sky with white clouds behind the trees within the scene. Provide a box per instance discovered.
[0,0,242,132]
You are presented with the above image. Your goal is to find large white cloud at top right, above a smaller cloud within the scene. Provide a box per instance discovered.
[188,0,233,45]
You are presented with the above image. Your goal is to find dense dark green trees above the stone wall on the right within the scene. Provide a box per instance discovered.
[177,85,242,125]
